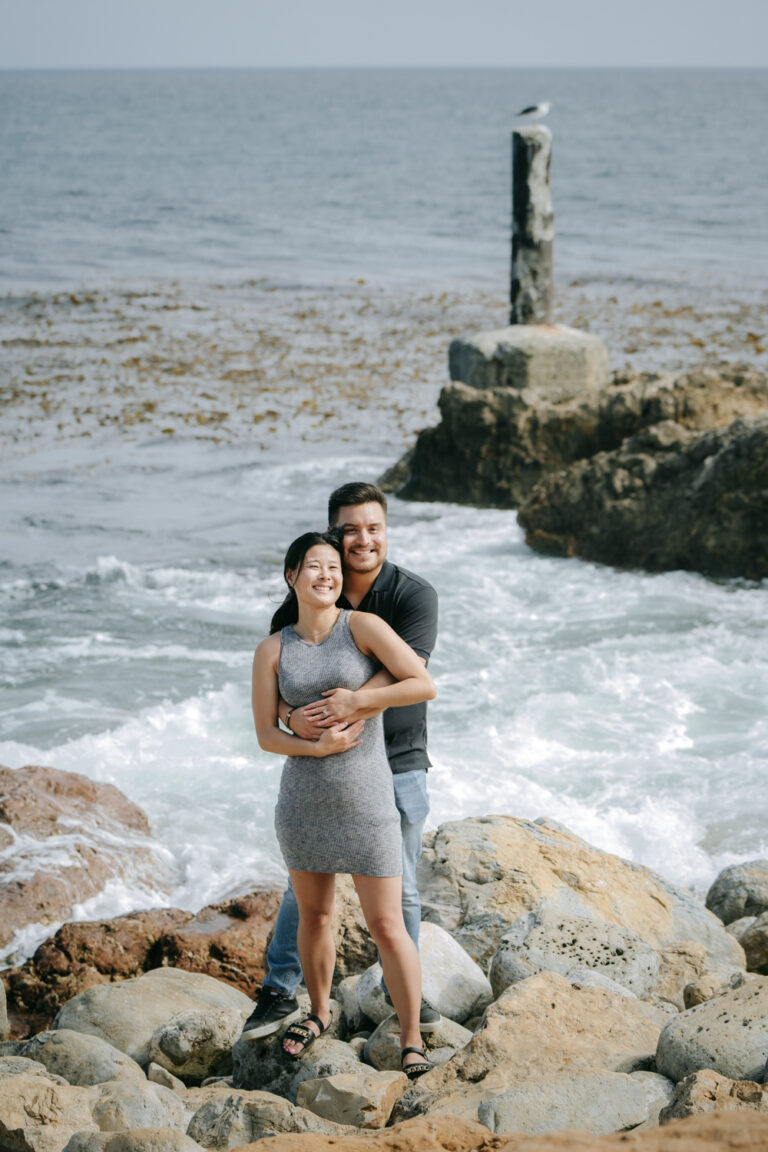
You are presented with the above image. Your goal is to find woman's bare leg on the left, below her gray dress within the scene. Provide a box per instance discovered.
[283,870,333,1055]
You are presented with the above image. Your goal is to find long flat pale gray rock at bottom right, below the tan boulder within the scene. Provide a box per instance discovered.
[478,1069,675,1135]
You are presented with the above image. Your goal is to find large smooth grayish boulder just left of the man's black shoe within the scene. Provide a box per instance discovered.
[53,968,251,1064]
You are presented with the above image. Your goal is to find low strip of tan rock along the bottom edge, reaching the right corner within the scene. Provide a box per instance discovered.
[225,1113,768,1152]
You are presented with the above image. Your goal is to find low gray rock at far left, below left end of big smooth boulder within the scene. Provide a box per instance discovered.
[10,1028,146,1086]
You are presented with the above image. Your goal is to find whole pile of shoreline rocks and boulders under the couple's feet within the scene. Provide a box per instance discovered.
[0,816,768,1152]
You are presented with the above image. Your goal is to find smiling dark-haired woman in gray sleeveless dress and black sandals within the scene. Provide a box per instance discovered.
[252,532,435,1079]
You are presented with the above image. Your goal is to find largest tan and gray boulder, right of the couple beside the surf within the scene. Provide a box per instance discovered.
[419,816,744,967]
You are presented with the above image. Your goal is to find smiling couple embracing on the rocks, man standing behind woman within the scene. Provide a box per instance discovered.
[251,483,440,1079]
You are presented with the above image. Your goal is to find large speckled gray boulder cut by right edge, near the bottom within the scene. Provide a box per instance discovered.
[656,976,768,1082]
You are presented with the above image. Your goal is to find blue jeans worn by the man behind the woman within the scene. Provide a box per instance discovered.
[264,768,429,996]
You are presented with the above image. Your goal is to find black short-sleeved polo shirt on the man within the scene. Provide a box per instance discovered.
[337,560,438,773]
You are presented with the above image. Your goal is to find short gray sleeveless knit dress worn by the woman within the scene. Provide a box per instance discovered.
[275,608,403,876]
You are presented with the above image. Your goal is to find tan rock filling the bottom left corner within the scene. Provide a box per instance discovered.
[0,1075,96,1152]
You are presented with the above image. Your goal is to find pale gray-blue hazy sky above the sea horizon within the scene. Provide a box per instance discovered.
[0,0,768,68]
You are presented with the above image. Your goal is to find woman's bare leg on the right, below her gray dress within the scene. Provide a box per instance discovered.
[352,876,423,1064]
